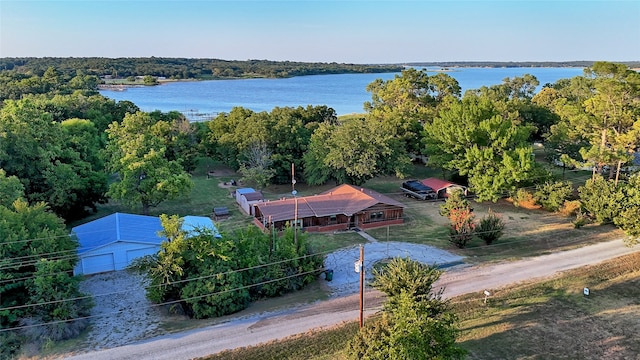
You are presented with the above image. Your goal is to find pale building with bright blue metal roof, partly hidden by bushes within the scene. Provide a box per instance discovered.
[72,213,219,275]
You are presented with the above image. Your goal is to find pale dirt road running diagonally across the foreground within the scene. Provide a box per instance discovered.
[63,240,637,360]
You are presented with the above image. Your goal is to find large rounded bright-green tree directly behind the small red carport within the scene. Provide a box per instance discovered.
[425,97,536,201]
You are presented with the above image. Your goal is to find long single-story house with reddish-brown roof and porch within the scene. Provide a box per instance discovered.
[254,185,405,232]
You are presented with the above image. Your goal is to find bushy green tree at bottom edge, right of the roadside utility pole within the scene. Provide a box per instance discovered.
[347,258,465,360]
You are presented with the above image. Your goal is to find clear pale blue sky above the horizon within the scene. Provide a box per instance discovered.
[0,0,640,64]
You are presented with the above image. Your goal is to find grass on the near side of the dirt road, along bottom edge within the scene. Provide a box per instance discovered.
[202,253,640,360]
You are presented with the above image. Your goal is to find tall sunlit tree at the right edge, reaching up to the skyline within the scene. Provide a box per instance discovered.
[547,62,640,179]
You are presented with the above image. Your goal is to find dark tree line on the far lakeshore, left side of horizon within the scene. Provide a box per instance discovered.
[0,57,403,79]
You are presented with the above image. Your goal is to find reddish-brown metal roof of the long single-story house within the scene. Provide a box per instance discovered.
[255,184,405,221]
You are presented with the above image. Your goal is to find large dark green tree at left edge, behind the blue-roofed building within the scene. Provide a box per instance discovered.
[0,99,106,219]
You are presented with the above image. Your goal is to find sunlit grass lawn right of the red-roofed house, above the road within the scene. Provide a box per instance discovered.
[365,167,623,262]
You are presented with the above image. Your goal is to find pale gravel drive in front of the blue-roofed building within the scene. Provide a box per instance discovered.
[80,271,162,351]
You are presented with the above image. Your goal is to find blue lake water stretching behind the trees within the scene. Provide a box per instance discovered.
[100,67,583,120]
